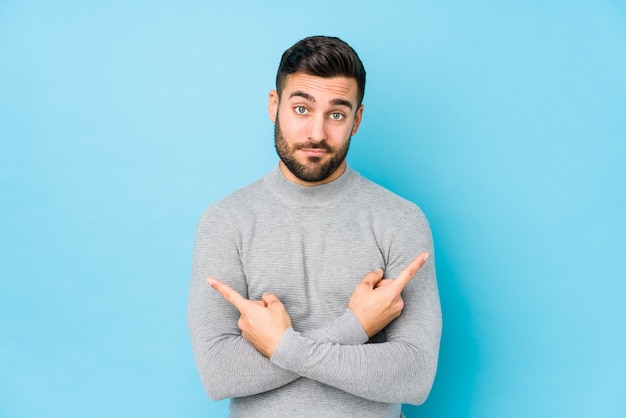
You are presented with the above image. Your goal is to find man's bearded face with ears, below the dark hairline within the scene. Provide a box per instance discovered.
[269,73,363,186]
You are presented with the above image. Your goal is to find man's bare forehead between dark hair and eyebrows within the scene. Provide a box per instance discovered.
[282,73,358,105]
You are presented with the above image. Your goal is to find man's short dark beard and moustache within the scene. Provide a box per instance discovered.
[274,116,351,183]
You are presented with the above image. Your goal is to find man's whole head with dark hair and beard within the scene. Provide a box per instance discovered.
[269,36,365,186]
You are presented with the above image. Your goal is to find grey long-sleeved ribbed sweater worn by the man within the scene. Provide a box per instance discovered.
[188,166,441,418]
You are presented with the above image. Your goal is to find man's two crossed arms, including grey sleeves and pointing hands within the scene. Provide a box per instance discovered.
[189,205,441,403]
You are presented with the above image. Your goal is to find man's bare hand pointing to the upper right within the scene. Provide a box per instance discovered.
[348,253,428,338]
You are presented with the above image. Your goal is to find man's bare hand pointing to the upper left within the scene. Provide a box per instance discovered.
[207,277,291,358]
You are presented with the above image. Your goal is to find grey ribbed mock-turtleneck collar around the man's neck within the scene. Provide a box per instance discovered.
[263,164,359,207]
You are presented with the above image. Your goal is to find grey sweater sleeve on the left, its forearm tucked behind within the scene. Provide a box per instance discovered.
[187,207,367,400]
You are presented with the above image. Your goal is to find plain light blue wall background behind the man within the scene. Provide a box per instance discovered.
[0,0,626,418]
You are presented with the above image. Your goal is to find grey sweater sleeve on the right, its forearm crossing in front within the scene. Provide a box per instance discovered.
[271,209,441,404]
